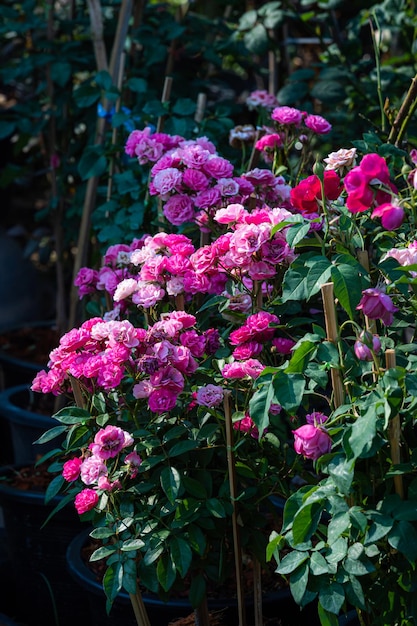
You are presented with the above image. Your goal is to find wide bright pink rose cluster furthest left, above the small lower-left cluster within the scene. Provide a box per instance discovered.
[32,311,220,414]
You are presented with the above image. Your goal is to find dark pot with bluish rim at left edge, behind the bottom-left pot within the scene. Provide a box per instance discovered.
[0,385,57,465]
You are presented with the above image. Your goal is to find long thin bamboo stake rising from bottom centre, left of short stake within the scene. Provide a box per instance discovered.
[223,391,246,626]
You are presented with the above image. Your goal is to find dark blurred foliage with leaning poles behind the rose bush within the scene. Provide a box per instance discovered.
[0,0,417,328]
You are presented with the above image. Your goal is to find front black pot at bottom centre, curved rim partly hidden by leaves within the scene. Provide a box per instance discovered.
[67,529,319,626]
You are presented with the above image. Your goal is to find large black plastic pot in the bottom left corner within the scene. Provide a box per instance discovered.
[0,460,88,626]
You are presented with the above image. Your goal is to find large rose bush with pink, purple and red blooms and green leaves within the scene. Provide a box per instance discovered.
[32,88,417,626]
